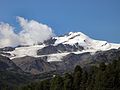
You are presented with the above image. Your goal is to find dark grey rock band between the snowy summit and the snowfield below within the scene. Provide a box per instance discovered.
[37,44,84,55]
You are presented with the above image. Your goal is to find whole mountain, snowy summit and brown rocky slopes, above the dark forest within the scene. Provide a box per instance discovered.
[0,32,120,74]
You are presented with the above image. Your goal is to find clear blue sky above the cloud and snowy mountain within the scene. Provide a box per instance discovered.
[0,0,120,43]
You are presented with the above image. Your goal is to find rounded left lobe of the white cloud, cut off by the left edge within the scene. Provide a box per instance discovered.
[0,23,20,48]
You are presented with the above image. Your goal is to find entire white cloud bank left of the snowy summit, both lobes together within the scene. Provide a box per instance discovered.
[0,17,54,48]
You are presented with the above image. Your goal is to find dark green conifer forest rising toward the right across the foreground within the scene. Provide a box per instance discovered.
[0,60,120,90]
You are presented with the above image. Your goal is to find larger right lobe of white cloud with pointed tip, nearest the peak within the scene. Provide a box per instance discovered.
[17,17,53,45]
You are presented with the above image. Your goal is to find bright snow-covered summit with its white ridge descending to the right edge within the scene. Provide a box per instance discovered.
[54,32,120,50]
